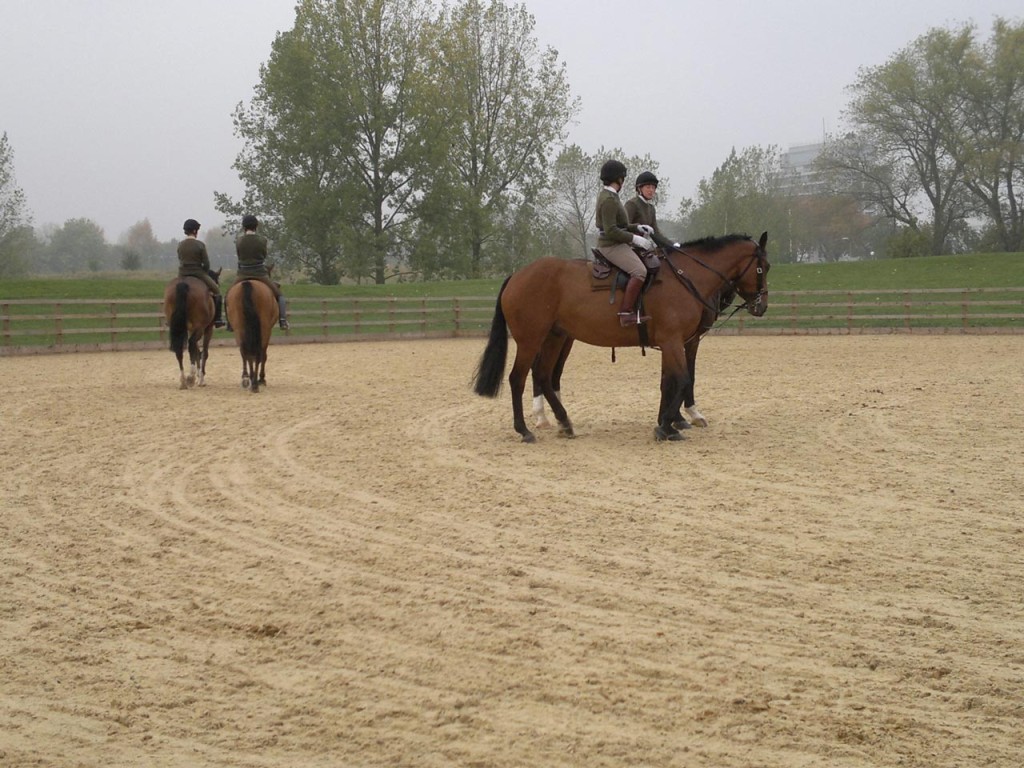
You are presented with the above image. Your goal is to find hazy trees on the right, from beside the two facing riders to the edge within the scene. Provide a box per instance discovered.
[679,18,1024,260]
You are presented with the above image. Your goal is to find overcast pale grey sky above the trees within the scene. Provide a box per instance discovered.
[0,0,1024,242]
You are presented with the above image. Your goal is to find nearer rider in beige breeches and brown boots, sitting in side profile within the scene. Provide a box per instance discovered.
[595,160,654,328]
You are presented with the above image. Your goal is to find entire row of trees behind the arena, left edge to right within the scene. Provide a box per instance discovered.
[0,9,1024,284]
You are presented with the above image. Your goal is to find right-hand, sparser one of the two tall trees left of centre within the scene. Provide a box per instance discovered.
[413,0,578,276]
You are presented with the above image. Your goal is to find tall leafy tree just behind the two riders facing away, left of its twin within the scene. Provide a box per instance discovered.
[217,0,430,283]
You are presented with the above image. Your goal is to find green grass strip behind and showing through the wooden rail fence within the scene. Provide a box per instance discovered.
[0,254,1024,346]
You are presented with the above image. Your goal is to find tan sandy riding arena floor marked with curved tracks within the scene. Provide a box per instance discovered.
[0,335,1024,768]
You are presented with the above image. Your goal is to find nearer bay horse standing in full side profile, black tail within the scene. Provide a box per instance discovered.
[473,232,770,442]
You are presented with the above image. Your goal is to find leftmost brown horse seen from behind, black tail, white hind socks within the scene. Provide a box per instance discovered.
[164,269,221,389]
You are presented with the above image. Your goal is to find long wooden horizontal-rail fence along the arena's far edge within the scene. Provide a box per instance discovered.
[0,288,1024,354]
